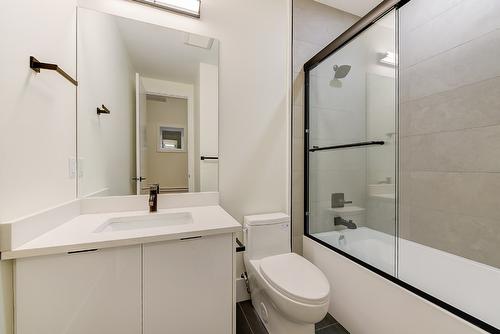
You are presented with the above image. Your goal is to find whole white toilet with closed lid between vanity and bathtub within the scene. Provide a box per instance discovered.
[243,213,330,334]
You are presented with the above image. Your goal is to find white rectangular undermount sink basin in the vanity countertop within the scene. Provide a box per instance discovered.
[94,212,193,233]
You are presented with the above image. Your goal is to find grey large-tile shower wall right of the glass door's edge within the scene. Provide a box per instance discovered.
[400,0,500,267]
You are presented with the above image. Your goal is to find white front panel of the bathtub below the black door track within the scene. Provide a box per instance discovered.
[303,237,486,334]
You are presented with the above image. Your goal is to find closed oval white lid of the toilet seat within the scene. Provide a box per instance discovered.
[259,253,330,304]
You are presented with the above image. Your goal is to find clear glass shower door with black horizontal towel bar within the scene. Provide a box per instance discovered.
[305,11,397,275]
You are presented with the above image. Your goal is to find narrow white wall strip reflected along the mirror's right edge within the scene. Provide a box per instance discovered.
[195,63,219,191]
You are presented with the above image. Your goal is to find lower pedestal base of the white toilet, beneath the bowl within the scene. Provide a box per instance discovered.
[251,276,314,334]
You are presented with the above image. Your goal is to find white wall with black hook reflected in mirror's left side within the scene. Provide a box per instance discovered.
[78,8,136,196]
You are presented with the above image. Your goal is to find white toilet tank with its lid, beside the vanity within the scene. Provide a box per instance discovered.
[243,212,291,260]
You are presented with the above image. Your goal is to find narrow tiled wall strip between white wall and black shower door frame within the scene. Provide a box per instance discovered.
[292,0,358,254]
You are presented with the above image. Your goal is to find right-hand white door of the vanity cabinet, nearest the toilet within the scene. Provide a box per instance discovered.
[143,234,234,334]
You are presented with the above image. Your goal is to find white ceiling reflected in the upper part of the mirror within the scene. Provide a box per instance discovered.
[115,17,219,84]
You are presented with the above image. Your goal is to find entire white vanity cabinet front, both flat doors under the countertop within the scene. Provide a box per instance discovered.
[15,233,235,334]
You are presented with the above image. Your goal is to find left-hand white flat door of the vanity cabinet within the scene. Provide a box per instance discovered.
[15,245,141,334]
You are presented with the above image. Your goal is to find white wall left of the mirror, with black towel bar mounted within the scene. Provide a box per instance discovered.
[0,0,76,334]
